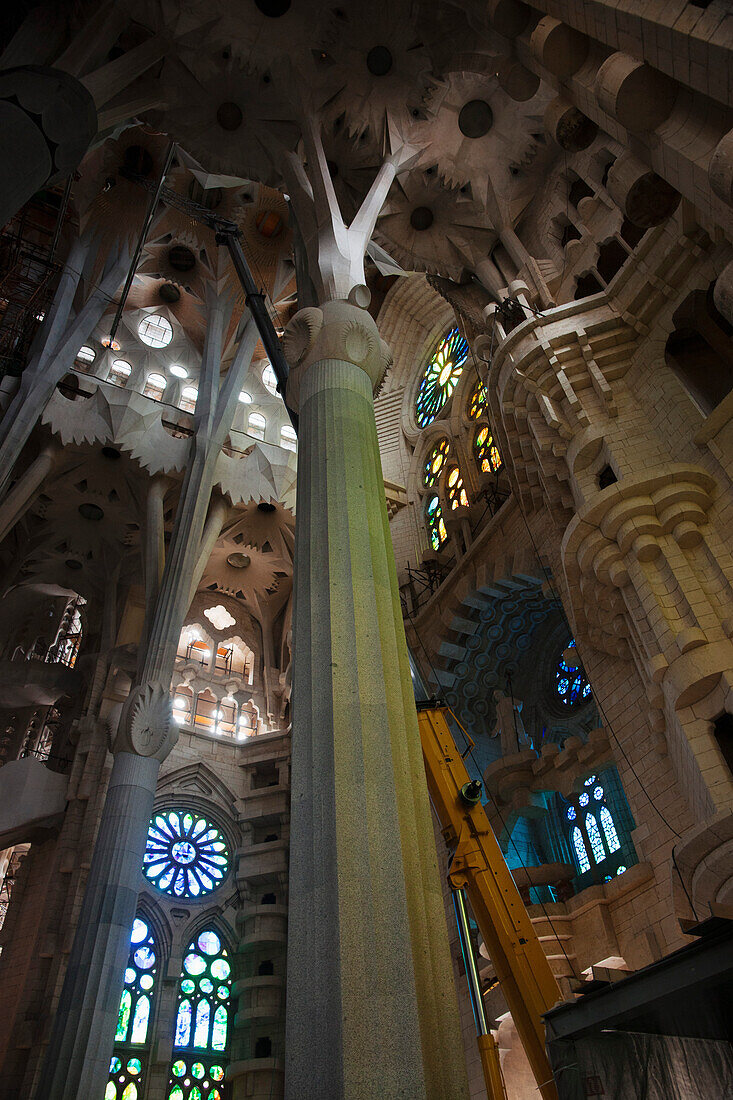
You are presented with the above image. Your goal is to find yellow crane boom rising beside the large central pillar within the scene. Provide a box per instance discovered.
[417,703,561,1100]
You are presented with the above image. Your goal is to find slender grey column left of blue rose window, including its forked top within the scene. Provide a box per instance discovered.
[35,290,258,1100]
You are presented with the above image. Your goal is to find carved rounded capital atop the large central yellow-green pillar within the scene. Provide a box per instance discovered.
[283,286,392,410]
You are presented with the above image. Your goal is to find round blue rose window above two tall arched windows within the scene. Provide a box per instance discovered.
[143,810,229,898]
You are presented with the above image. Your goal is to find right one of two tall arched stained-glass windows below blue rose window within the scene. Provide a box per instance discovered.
[166,928,231,1100]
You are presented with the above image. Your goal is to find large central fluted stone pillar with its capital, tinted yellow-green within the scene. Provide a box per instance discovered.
[285,301,467,1100]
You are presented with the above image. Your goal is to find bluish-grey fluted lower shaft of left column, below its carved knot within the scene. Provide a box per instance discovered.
[35,752,161,1100]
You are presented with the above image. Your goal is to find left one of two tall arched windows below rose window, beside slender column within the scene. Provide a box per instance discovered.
[105,915,158,1100]
